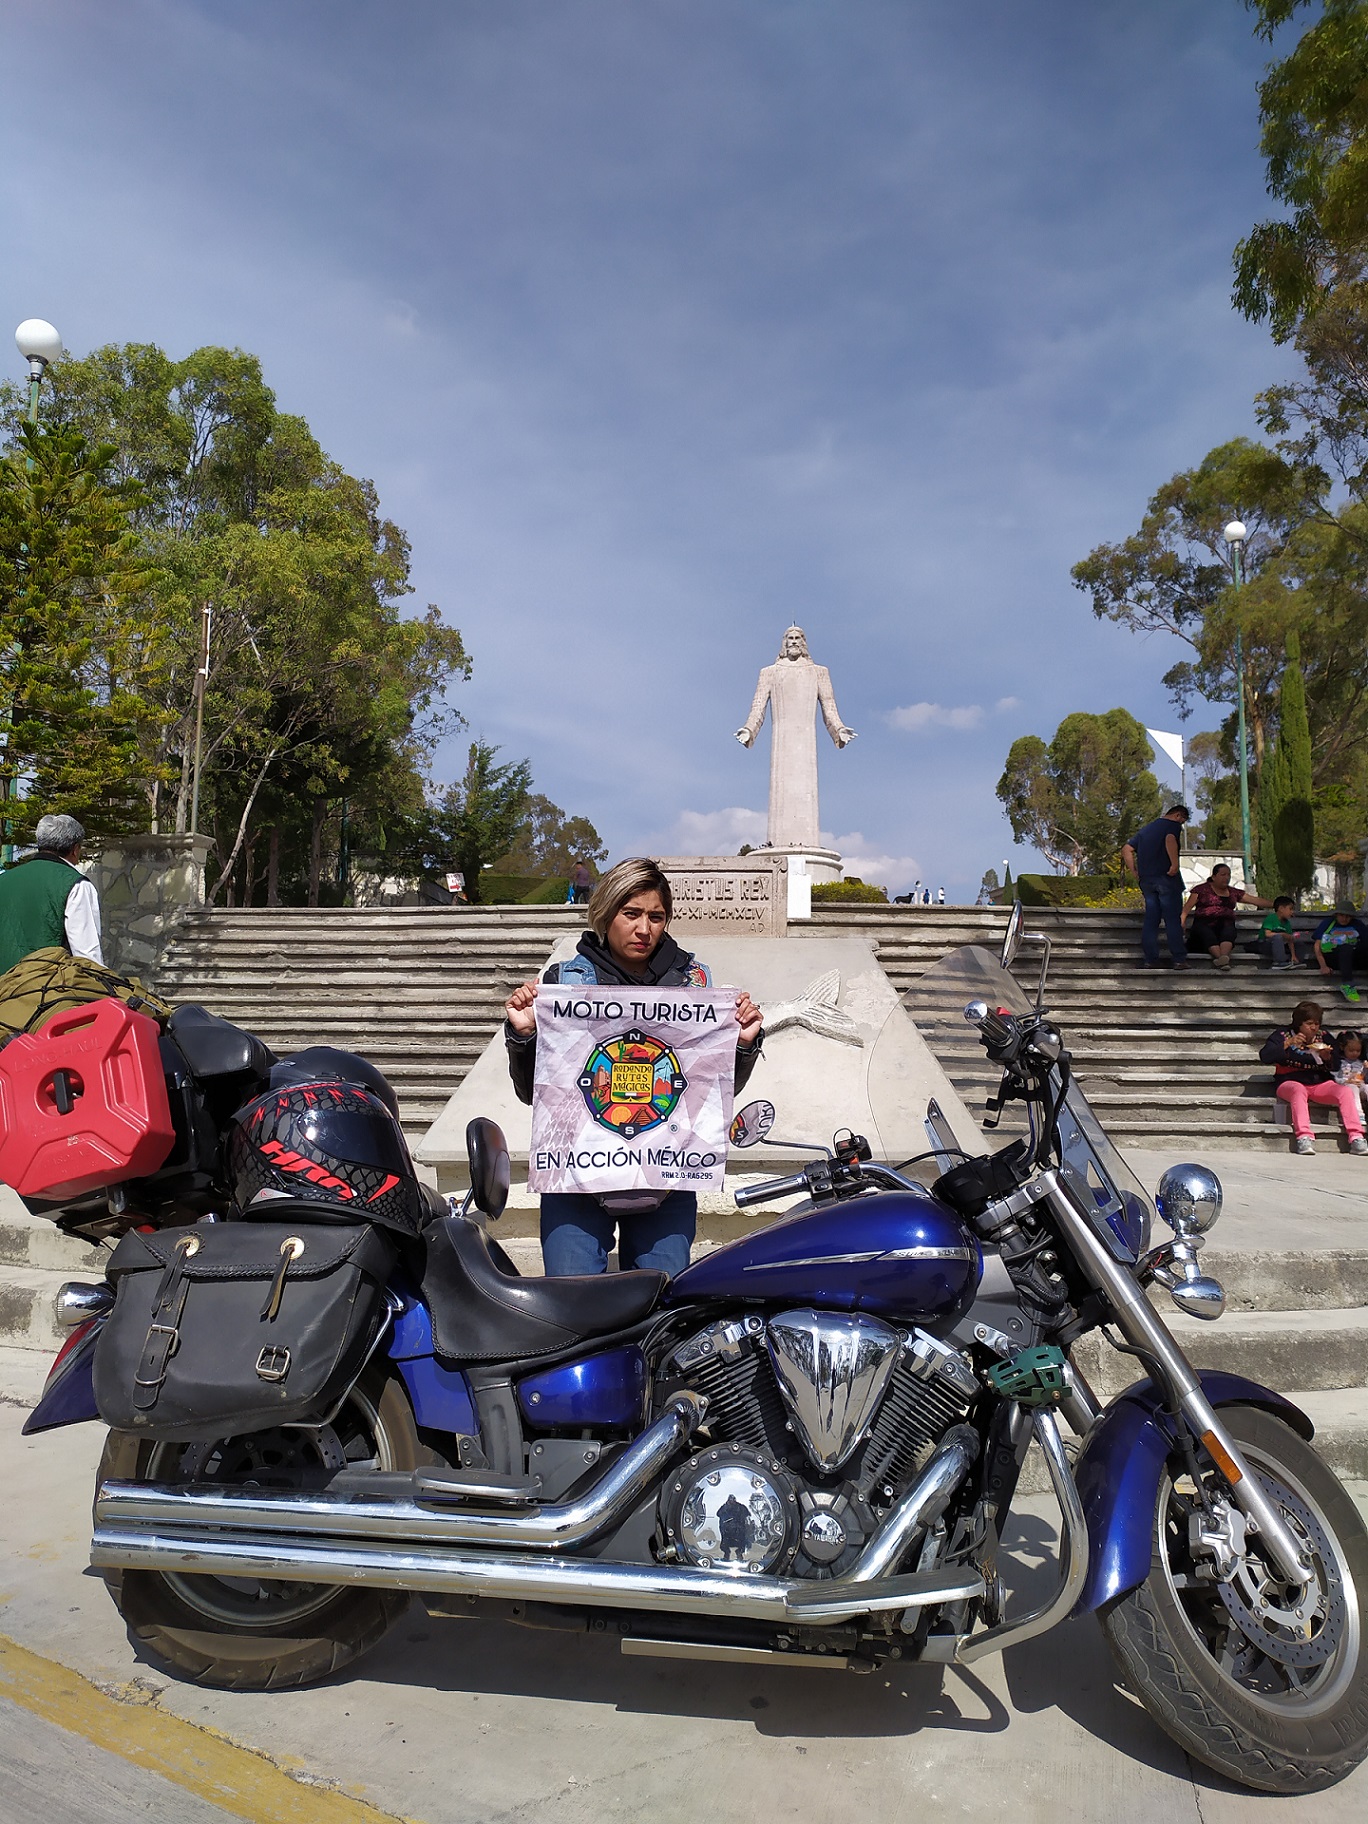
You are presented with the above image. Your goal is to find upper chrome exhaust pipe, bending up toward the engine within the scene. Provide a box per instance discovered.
[95,1388,708,1550]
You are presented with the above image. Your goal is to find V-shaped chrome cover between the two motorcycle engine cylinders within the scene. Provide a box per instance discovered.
[764,1310,905,1476]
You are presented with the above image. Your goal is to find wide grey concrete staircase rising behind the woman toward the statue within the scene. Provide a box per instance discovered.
[139,907,1368,1149]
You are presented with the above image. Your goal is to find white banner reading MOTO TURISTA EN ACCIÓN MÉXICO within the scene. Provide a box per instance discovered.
[527,983,737,1193]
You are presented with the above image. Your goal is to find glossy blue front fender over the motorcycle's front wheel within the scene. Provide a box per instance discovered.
[1073,1372,1315,1614]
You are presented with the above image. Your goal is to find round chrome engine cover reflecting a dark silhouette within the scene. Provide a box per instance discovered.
[660,1445,801,1576]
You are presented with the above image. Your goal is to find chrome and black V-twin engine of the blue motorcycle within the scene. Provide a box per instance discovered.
[658,1310,979,1578]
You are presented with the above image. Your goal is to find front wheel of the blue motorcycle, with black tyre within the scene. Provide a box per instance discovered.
[1102,1406,1368,1793]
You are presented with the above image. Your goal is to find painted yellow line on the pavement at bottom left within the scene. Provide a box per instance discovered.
[0,1634,423,1824]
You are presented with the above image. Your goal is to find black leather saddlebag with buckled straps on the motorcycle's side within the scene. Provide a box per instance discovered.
[95,1222,394,1443]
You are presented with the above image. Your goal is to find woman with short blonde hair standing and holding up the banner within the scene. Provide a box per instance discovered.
[503,859,764,1275]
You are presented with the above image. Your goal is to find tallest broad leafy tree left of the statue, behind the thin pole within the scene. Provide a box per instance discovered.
[0,343,471,903]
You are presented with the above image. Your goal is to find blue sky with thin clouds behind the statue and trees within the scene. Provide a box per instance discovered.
[0,0,1290,897]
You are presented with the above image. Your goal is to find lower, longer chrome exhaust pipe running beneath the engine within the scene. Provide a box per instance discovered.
[91,1523,983,1627]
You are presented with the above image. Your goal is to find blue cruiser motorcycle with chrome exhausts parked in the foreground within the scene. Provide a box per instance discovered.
[26,908,1368,1793]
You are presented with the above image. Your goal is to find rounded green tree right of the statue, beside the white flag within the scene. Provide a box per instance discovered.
[998,710,1162,874]
